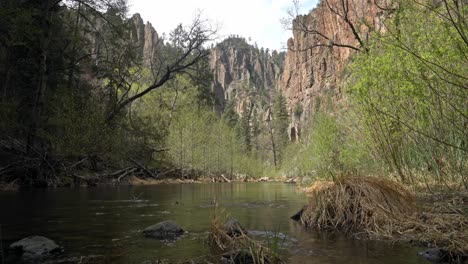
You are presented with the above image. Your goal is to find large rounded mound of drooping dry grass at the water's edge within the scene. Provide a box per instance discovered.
[301,176,415,233]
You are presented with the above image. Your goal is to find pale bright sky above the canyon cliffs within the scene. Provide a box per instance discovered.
[128,0,317,50]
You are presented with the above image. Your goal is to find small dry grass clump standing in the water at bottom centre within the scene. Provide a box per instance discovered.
[208,208,285,264]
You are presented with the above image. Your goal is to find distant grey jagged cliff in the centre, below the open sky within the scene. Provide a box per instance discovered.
[210,37,282,113]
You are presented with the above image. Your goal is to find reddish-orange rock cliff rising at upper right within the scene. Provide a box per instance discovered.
[279,0,385,136]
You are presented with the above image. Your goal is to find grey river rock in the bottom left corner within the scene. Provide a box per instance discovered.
[9,236,63,260]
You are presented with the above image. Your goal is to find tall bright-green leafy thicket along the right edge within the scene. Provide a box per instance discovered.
[349,2,468,185]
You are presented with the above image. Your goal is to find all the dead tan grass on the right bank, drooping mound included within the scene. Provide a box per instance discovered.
[301,176,468,253]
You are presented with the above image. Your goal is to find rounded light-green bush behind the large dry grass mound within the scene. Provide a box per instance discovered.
[282,112,372,178]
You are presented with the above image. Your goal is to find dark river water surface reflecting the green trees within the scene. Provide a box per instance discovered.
[0,183,426,264]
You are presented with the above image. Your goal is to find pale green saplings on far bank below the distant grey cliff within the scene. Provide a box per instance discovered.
[167,107,262,176]
